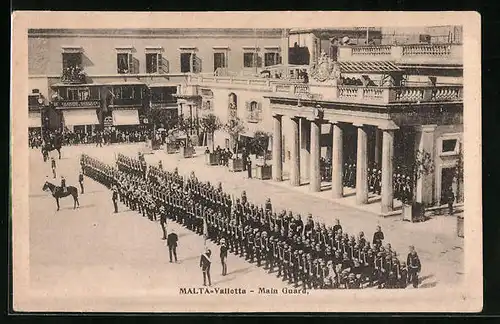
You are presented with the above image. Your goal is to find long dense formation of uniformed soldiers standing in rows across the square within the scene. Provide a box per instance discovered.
[81,154,421,289]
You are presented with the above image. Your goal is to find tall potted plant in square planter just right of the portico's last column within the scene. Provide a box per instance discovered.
[403,150,434,222]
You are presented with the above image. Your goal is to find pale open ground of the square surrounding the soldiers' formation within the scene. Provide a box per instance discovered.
[29,144,463,295]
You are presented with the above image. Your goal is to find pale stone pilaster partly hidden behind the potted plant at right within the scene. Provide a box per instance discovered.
[415,125,441,205]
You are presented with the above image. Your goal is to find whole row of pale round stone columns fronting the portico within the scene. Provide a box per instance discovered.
[272,114,394,213]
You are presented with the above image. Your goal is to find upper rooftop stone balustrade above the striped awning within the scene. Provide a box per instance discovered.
[338,44,463,65]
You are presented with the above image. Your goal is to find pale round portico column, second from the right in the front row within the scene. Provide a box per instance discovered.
[354,125,368,204]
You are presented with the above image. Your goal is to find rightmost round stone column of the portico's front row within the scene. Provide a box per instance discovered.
[377,129,394,213]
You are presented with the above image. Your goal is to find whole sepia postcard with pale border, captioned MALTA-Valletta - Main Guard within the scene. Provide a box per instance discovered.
[10,11,483,313]
